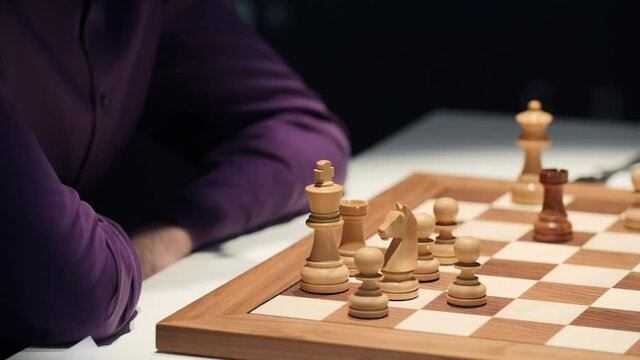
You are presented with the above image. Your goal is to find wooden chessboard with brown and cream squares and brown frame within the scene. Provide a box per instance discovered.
[156,173,640,359]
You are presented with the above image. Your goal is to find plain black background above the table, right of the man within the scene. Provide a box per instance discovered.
[238,0,640,153]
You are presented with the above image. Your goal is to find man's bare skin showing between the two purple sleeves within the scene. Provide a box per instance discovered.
[131,225,193,279]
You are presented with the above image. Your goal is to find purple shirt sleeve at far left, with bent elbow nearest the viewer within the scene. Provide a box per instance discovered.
[0,96,142,345]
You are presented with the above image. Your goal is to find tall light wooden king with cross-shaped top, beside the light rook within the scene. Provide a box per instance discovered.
[300,160,349,294]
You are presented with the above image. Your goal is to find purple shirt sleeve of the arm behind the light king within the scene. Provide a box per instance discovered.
[147,1,350,247]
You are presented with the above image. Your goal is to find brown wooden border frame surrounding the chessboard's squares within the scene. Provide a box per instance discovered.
[156,173,632,359]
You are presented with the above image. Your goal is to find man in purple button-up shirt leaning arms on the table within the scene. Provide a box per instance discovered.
[0,0,350,344]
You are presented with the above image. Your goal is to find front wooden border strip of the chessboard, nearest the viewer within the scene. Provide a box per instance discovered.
[158,314,633,360]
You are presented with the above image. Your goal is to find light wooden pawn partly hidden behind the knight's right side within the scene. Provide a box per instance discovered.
[413,213,440,282]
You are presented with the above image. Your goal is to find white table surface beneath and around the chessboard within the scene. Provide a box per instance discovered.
[12,110,640,359]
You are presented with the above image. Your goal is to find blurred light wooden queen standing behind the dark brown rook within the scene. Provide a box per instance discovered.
[511,100,553,204]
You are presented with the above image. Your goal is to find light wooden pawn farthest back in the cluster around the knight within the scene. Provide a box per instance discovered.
[430,197,458,265]
